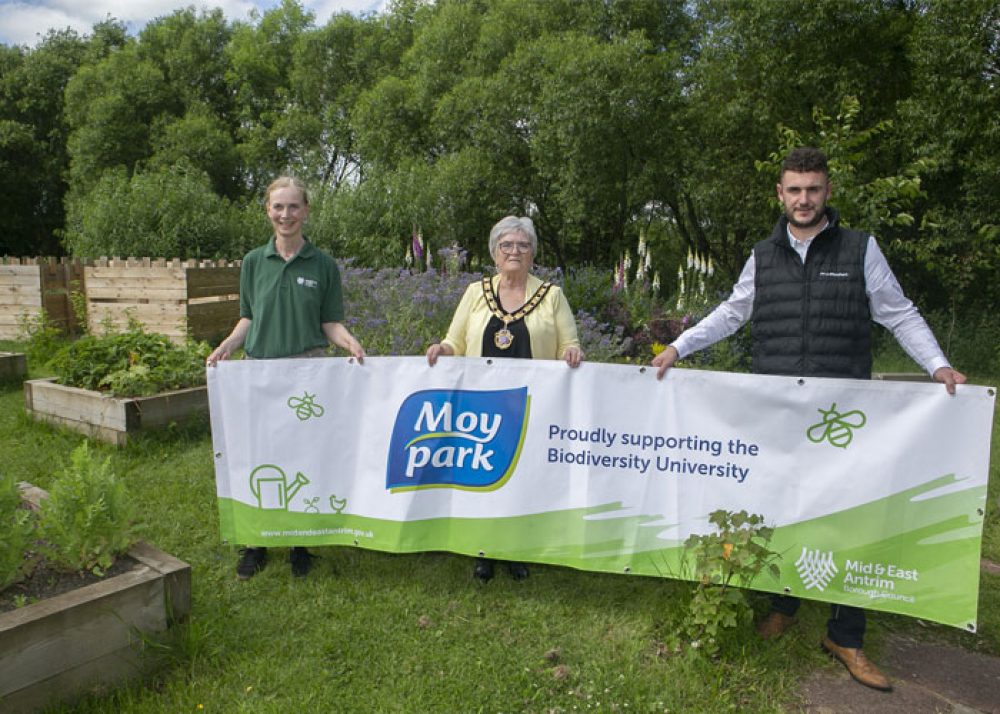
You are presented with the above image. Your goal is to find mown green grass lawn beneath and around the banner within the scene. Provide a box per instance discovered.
[0,343,1000,714]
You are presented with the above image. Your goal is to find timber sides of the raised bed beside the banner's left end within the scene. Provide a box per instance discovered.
[24,378,208,445]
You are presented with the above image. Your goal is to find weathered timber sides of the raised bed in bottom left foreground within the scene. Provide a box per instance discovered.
[0,484,191,714]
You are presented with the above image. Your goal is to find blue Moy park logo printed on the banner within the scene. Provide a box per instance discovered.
[385,387,531,493]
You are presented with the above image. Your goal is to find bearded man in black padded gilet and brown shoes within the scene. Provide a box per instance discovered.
[653,148,965,692]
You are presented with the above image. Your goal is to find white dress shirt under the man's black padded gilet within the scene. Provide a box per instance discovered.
[672,225,951,376]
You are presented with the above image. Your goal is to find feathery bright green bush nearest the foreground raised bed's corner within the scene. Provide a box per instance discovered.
[39,442,137,575]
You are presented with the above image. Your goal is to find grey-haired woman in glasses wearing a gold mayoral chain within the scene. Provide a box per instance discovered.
[427,216,584,583]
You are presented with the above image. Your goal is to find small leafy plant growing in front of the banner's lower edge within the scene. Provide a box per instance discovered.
[684,509,779,654]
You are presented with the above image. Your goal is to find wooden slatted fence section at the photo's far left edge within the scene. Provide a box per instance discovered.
[0,257,86,340]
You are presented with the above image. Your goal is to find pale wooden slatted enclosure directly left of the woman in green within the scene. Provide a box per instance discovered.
[84,258,240,342]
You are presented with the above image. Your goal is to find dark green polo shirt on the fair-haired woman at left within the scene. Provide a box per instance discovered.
[240,238,344,359]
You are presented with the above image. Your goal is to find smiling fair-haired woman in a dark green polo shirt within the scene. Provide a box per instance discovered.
[208,176,365,580]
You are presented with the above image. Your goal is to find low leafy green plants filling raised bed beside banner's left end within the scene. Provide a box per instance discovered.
[49,318,209,397]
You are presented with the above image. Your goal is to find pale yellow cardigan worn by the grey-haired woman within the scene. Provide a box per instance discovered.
[441,275,580,359]
